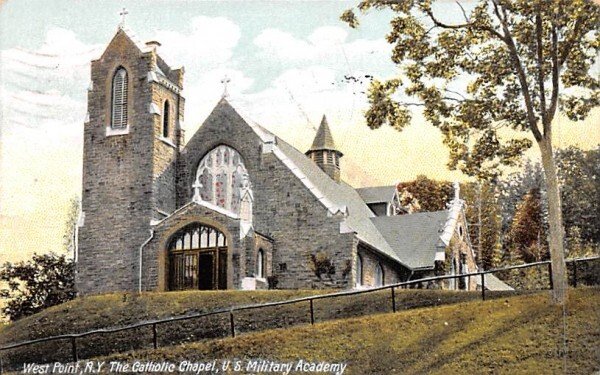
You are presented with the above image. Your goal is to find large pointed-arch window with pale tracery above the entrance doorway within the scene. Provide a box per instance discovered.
[195,145,253,221]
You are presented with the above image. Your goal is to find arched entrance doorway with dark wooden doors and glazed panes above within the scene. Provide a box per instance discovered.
[167,223,227,290]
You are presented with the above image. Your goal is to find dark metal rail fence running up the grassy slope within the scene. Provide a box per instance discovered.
[0,256,600,374]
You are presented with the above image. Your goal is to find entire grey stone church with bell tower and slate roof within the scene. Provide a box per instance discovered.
[76,27,476,295]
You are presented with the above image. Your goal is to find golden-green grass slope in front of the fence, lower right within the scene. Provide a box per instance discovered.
[96,287,600,375]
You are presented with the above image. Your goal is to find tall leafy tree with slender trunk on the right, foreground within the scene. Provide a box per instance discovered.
[341,0,600,304]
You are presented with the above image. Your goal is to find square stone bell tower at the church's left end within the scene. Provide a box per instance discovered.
[76,19,184,294]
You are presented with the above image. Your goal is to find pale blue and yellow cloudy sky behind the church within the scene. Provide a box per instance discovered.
[0,0,600,263]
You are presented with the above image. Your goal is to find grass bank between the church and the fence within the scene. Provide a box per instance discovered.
[0,289,520,366]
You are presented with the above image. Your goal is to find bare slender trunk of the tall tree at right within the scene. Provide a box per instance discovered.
[538,136,567,304]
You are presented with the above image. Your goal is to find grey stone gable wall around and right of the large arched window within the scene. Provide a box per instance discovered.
[178,101,354,288]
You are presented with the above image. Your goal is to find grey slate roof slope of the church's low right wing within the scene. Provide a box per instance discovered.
[371,211,448,269]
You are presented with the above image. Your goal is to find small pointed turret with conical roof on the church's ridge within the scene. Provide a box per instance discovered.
[306,115,343,182]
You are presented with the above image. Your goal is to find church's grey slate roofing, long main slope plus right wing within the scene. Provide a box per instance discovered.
[210,98,449,269]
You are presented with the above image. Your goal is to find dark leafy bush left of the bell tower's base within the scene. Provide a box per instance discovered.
[0,253,76,320]
